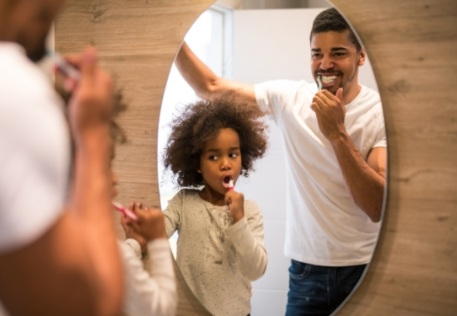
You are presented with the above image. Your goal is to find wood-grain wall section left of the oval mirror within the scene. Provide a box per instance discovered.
[55,0,212,316]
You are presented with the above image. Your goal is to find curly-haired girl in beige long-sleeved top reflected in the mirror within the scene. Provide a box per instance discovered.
[160,92,267,316]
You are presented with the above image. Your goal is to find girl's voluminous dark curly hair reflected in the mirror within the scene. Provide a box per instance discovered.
[163,91,268,187]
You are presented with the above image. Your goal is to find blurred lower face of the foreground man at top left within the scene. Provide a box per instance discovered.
[15,0,65,61]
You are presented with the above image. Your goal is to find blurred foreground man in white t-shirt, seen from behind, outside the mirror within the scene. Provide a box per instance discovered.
[0,0,123,315]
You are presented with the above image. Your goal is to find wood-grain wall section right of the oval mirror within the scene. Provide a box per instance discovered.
[332,0,457,315]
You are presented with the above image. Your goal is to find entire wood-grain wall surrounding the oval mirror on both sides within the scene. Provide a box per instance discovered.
[55,0,457,315]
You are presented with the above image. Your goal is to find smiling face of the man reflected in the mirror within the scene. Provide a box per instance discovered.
[311,31,365,94]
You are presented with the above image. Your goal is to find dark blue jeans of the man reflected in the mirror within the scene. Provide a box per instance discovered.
[286,260,366,316]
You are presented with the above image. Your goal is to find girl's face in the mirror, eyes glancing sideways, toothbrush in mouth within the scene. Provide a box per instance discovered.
[199,128,241,199]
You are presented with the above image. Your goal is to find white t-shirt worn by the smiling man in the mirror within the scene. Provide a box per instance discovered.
[255,80,386,266]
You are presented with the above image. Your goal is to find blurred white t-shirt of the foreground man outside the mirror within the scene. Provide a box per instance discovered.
[0,42,71,254]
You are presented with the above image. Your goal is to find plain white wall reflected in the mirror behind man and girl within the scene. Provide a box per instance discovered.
[231,9,377,316]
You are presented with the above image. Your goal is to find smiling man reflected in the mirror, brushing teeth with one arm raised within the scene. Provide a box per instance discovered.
[176,8,387,315]
